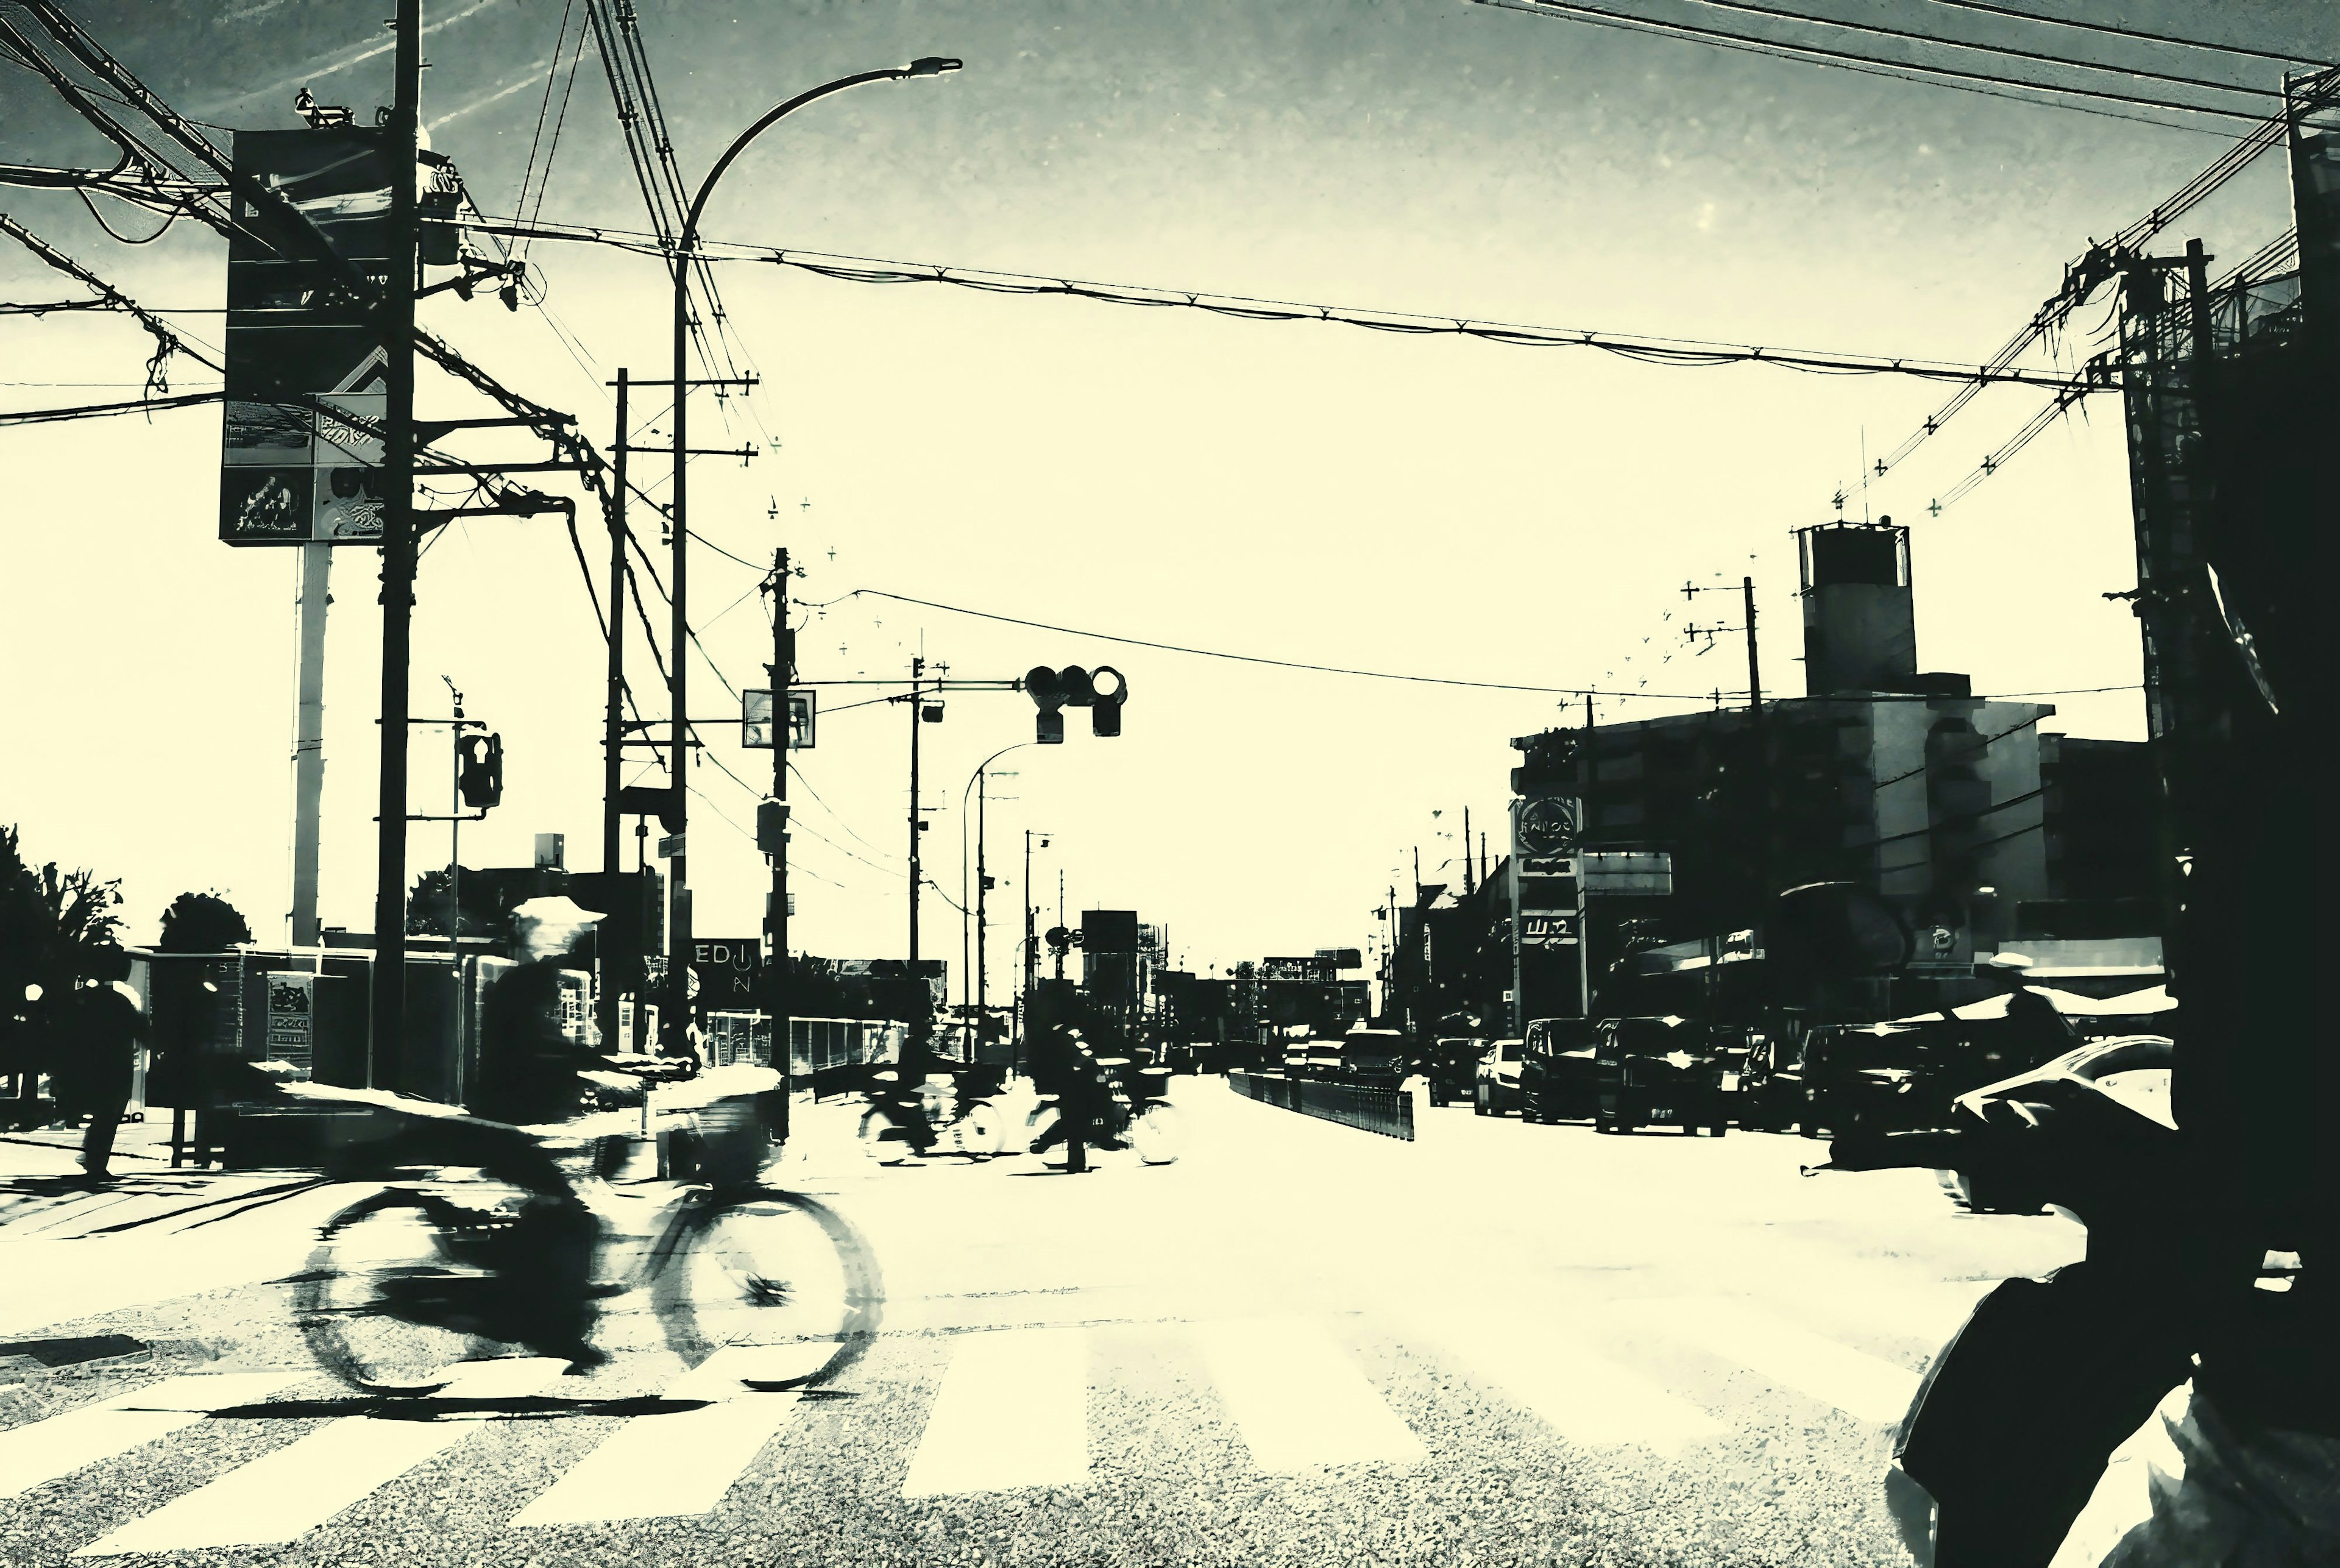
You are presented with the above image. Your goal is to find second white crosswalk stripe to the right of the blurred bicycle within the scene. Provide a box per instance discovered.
[1191,1318,1423,1470]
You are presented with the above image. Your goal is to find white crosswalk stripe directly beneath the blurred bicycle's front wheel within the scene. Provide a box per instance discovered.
[512,1348,803,1528]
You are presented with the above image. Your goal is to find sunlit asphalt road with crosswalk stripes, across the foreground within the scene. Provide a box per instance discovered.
[0,1079,2080,1568]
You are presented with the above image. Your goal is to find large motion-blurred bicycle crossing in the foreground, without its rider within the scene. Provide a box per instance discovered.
[295,1067,885,1397]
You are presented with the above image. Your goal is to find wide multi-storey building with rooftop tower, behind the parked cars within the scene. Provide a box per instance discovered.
[1497,520,2157,1030]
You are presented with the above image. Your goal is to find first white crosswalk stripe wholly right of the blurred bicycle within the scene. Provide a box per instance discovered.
[901,1329,1088,1498]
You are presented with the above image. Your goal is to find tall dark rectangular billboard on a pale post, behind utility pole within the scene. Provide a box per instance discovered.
[220,126,395,545]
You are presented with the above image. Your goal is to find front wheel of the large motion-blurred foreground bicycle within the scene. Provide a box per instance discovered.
[653,1187,885,1388]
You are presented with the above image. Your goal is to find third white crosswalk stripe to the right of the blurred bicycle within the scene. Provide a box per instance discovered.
[1409,1308,1727,1453]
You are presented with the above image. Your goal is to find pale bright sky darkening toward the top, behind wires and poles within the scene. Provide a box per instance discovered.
[0,0,2340,995]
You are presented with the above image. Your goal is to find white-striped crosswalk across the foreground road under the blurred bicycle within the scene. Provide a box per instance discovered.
[0,1297,1956,1559]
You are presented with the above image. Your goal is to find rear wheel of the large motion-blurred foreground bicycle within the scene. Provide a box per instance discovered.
[292,1189,496,1397]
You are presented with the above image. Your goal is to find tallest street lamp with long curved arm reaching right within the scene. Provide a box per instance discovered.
[665,56,962,1053]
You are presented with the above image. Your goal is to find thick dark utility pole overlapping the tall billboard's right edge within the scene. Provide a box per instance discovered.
[365,0,424,1088]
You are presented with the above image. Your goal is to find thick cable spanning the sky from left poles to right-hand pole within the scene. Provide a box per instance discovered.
[452,218,2101,391]
